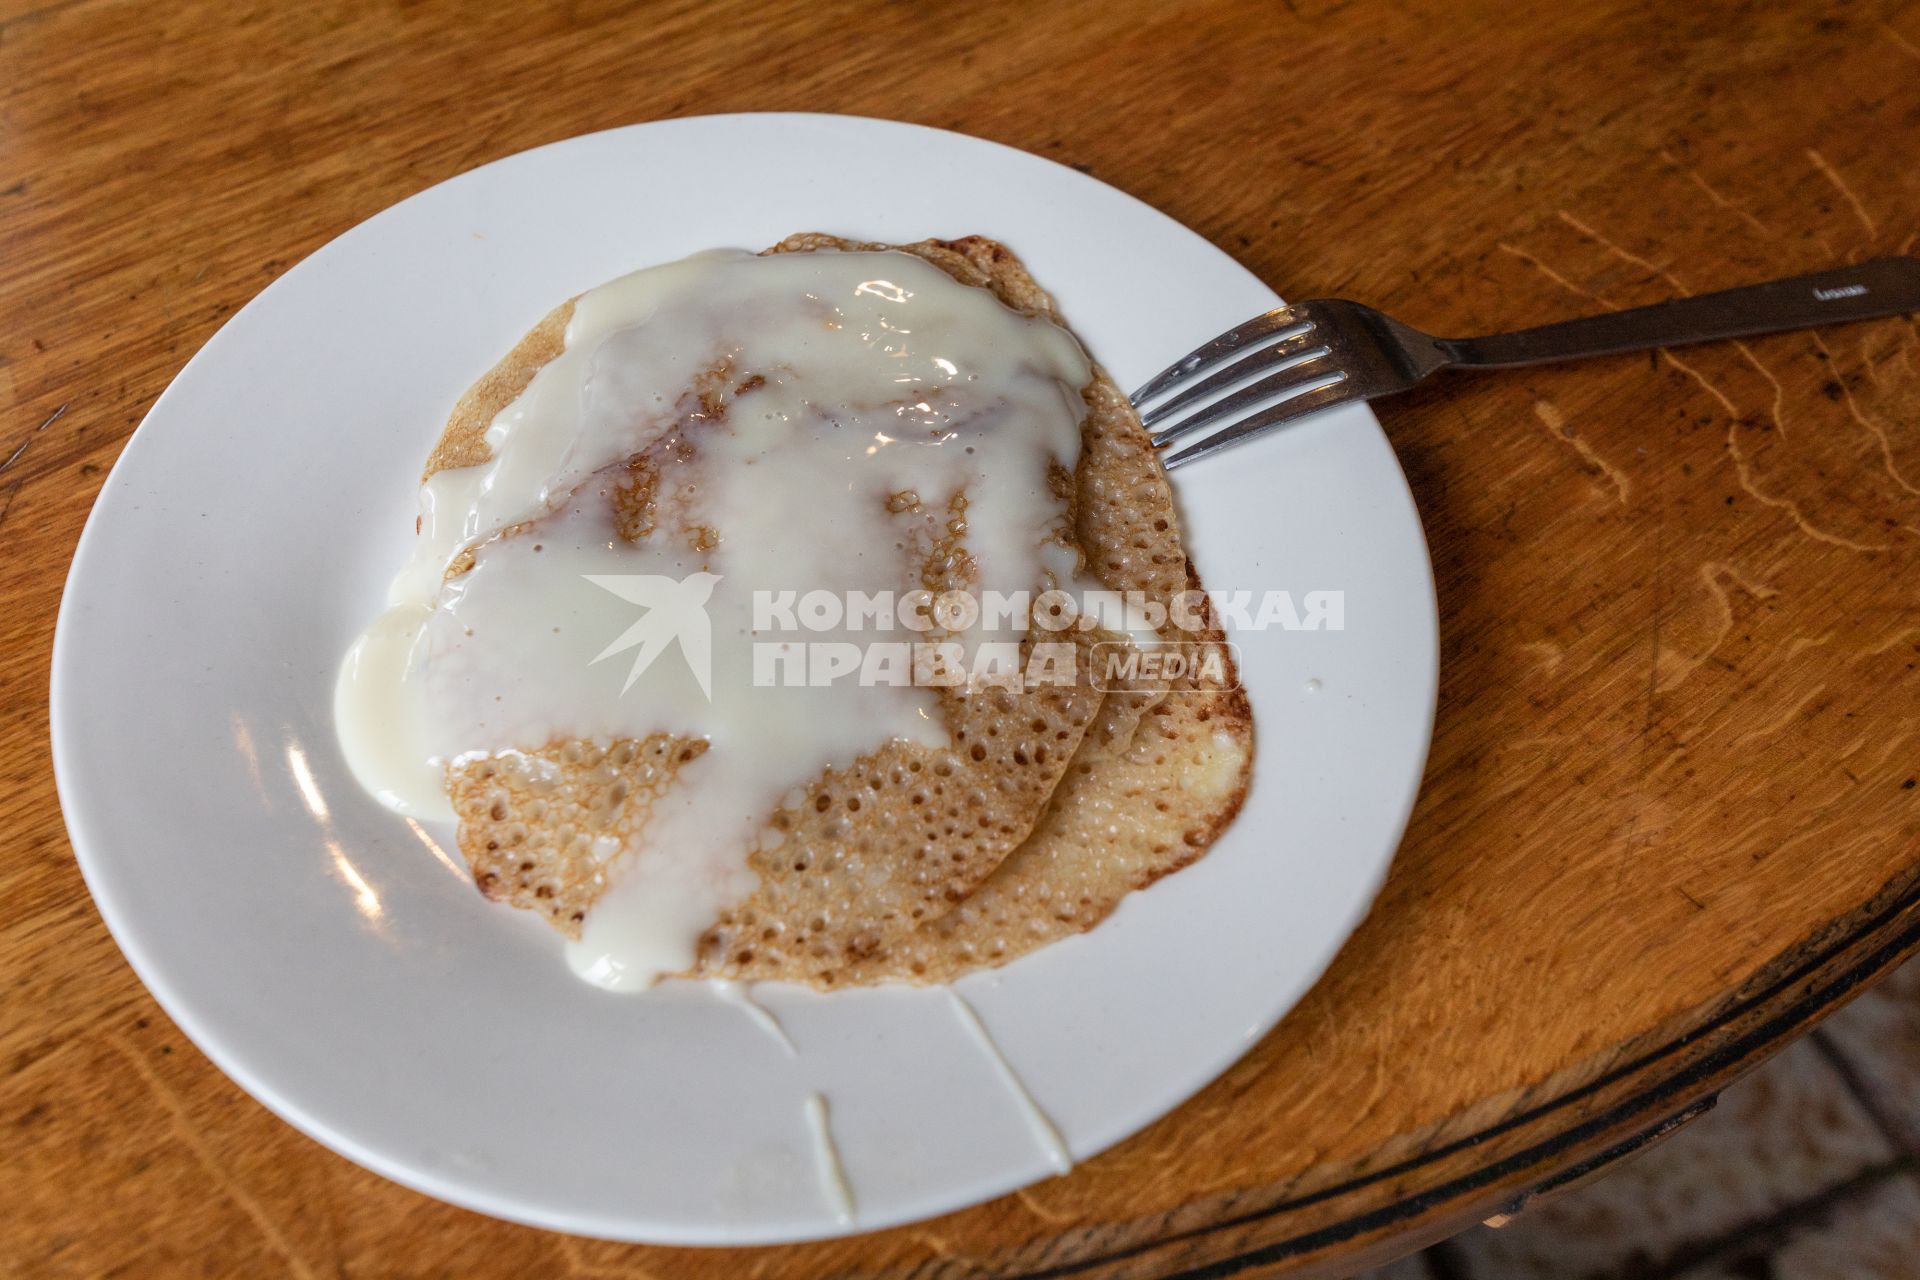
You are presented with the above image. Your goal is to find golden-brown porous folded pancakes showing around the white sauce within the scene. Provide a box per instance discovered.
[414,234,1252,986]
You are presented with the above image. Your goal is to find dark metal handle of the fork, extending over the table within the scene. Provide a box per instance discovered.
[1434,257,1920,368]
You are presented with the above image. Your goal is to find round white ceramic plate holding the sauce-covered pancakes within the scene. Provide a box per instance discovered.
[52,115,1436,1244]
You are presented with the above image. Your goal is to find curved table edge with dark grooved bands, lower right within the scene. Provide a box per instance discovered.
[975,867,1920,1280]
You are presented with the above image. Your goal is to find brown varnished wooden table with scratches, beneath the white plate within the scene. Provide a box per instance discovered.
[0,0,1920,1278]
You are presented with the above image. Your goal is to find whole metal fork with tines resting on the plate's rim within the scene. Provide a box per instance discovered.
[1133,257,1920,470]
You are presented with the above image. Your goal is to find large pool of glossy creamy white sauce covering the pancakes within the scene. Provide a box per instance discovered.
[336,251,1091,990]
